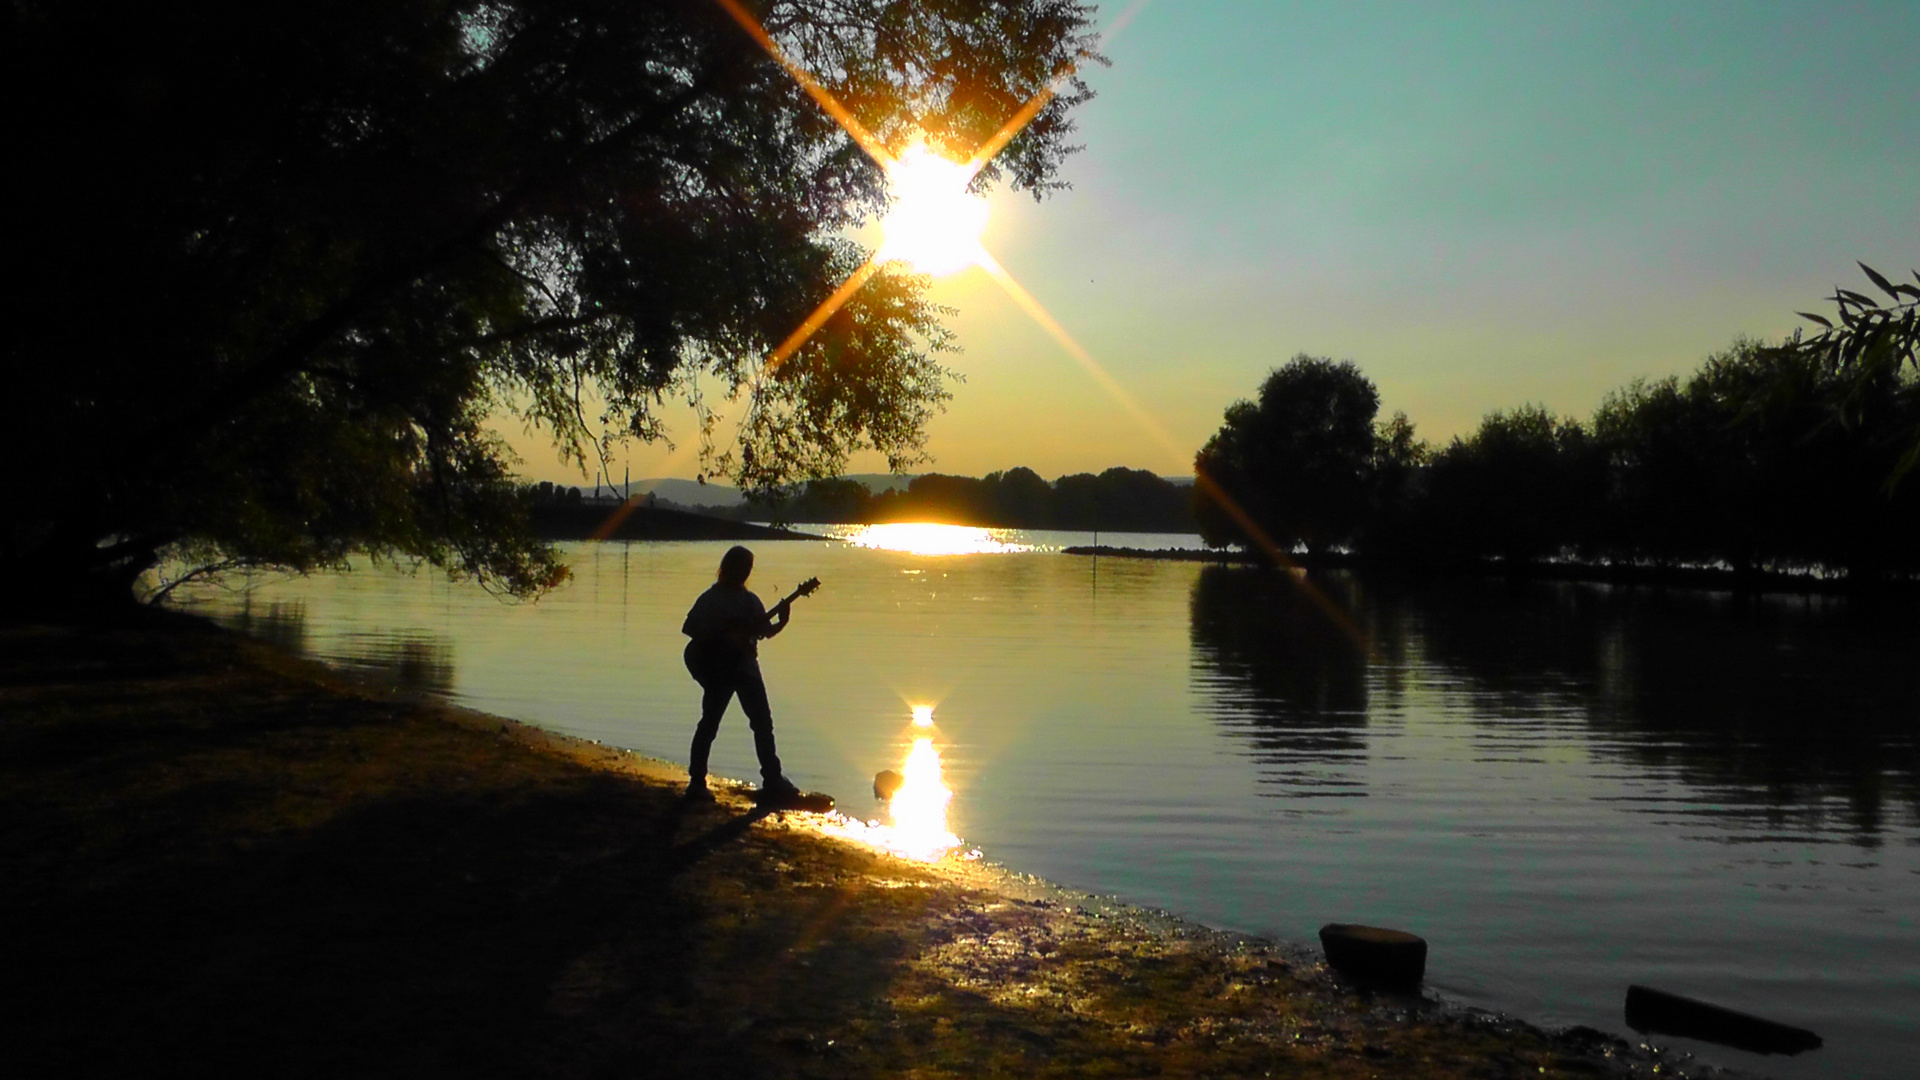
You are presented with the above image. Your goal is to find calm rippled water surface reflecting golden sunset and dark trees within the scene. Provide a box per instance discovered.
[172,530,1920,1080]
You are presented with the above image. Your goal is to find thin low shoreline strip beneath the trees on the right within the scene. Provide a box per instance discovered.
[1062,546,1920,598]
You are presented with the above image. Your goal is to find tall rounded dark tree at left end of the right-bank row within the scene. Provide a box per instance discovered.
[1194,354,1382,550]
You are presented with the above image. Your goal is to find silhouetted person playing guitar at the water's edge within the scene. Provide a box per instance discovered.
[680,544,801,803]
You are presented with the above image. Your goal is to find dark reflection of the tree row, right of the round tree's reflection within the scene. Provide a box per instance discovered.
[1405,582,1920,842]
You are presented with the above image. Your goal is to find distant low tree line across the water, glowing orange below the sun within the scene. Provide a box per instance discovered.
[732,467,1194,532]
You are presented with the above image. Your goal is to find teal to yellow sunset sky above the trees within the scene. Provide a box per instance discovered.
[507,0,1920,482]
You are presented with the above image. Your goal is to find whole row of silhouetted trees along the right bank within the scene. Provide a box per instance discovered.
[1196,267,1920,580]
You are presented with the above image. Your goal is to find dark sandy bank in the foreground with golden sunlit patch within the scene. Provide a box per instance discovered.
[0,619,1751,1080]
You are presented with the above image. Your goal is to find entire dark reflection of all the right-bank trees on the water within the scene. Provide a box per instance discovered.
[1192,567,1920,844]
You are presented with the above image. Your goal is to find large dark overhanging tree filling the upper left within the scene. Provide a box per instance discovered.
[0,0,1096,605]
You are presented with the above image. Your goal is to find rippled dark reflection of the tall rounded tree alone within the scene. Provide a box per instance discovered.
[1192,567,1367,798]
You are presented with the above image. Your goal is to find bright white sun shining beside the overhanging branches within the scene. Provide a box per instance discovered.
[877,144,987,277]
